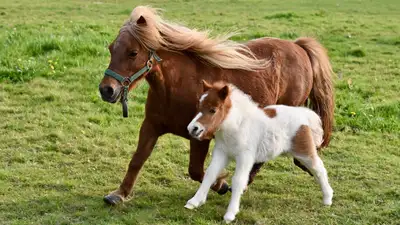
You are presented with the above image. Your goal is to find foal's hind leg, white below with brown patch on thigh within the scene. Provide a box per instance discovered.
[292,126,333,205]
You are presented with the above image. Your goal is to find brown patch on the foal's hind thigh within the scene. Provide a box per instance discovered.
[292,125,316,156]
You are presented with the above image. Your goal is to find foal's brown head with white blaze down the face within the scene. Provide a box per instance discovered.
[187,80,232,140]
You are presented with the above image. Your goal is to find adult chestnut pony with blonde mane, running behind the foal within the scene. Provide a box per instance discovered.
[99,6,334,205]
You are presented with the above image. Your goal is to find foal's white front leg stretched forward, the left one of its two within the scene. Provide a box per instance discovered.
[185,149,228,209]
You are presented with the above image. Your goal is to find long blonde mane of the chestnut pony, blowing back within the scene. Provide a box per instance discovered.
[121,6,269,71]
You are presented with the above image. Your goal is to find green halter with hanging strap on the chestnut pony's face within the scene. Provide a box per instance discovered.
[104,51,162,117]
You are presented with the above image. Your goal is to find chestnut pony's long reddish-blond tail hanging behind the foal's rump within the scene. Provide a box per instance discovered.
[295,38,335,147]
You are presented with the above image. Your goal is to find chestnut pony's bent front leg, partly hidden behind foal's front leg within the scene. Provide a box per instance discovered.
[189,139,229,195]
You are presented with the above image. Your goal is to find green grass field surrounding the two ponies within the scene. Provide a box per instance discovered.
[0,0,400,224]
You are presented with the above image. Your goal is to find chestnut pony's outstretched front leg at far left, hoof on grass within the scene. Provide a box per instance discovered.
[104,119,162,205]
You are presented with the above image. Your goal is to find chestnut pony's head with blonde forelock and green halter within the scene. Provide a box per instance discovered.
[99,6,161,103]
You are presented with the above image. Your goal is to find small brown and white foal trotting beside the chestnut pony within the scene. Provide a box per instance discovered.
[185,81,333,223]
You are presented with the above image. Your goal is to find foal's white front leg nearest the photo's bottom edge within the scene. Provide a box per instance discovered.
[224,154,254,223]
